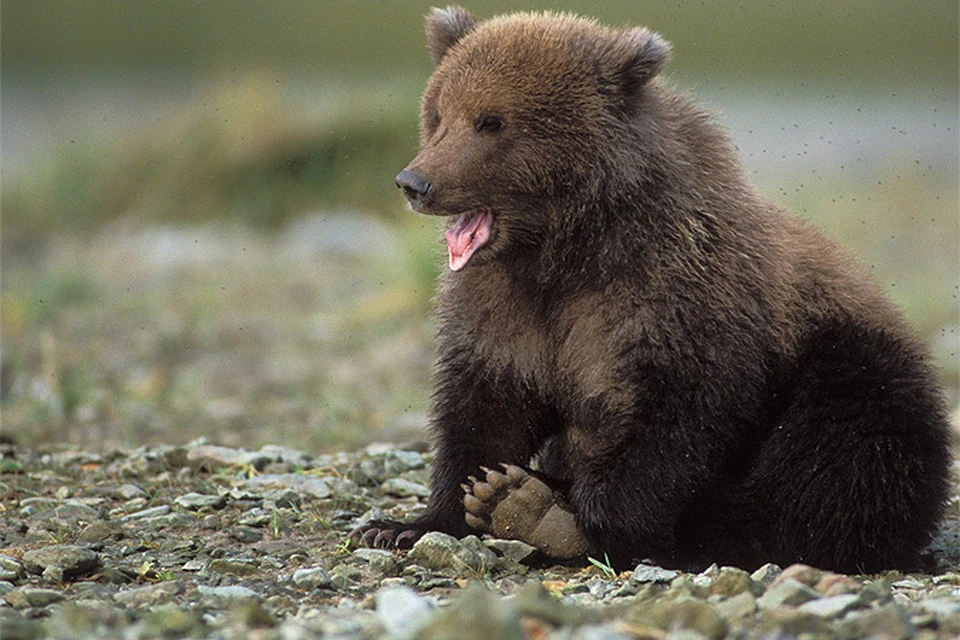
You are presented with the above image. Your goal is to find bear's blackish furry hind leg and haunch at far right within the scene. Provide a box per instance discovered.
[738,327,951,572]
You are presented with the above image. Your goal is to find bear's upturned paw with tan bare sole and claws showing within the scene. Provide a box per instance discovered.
[462,464,588,559]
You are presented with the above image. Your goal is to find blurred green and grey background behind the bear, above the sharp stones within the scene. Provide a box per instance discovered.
[0,0,960,452]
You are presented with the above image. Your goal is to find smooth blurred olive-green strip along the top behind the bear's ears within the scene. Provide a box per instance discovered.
[2,0,958,85]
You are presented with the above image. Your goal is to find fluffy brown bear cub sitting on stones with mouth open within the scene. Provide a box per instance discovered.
[353,7,951,572]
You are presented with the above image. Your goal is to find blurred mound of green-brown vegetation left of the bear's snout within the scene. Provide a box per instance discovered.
[4,70,417,232]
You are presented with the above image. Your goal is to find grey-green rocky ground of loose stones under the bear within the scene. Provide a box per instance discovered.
[0,440,960,640]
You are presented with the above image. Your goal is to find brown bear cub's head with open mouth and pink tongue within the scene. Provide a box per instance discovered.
[397,7,670,271]
